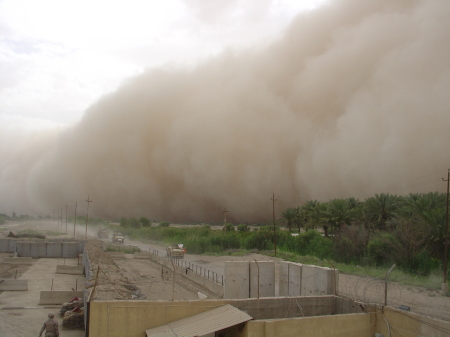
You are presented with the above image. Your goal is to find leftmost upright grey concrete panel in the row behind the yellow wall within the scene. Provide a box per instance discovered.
[224,261,250,298]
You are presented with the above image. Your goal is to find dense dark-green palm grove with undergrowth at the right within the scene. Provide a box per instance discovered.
[281,192,446,274]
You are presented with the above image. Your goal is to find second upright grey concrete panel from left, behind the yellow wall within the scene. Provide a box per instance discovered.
[250,261,275,298]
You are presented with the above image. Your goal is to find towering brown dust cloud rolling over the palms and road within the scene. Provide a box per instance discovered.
[0,0,450,221]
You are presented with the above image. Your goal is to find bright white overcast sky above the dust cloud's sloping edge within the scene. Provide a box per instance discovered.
[0,0,323,128]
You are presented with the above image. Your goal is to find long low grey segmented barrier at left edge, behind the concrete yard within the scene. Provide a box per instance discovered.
[0,239,85,259]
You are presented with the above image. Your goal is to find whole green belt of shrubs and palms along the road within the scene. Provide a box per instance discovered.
[108,193,446,288]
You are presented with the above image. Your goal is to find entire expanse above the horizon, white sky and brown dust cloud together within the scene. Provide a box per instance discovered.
[0,0,450,222]
